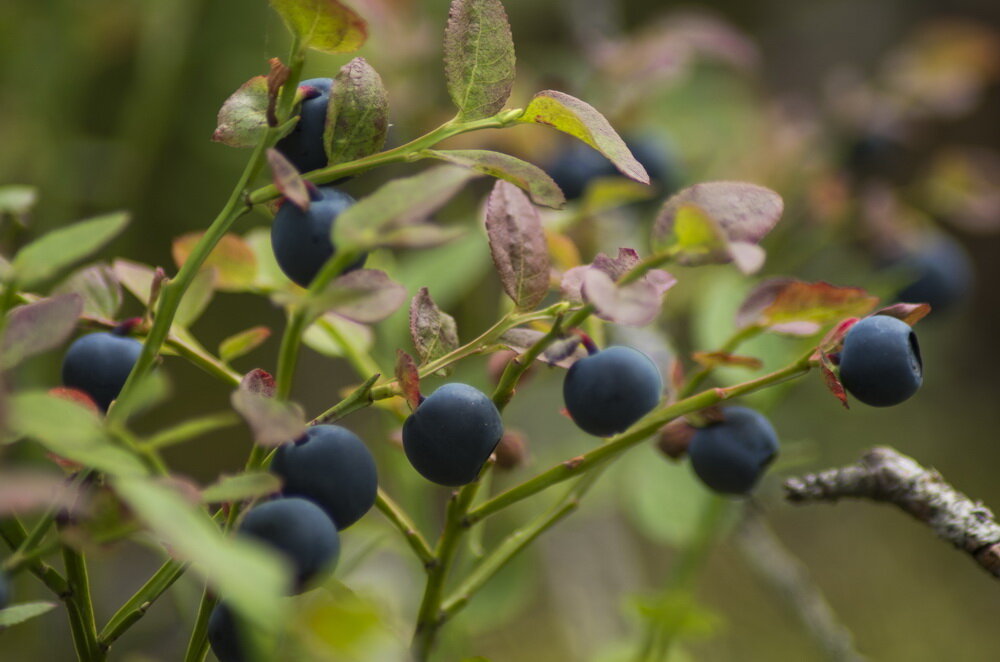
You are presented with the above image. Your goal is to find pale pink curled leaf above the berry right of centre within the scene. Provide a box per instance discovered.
[581,269,677,326]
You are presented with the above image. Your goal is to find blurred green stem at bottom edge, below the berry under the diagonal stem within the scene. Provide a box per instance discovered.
[636,494,730,662]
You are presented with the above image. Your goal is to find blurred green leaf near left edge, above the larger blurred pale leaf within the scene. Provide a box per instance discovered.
[8,391,146,475]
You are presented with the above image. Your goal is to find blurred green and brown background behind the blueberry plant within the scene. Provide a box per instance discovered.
[0,0,1000,662]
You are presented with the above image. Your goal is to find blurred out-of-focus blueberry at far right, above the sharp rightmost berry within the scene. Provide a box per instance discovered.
[893,235,973,312]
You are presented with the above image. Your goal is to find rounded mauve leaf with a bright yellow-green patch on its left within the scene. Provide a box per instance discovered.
[653,182,784,273]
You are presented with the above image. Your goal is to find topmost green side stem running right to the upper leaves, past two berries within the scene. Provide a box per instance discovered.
[249,109,523,205]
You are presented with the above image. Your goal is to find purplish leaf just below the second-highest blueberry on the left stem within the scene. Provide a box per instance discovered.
[310,269,406,324]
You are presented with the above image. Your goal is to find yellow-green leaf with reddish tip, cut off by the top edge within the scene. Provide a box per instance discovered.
[271,0,368,53]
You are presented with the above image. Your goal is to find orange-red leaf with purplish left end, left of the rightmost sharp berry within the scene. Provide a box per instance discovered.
[736,278,878,336]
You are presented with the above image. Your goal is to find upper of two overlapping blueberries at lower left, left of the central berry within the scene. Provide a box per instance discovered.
[271,425,378,530]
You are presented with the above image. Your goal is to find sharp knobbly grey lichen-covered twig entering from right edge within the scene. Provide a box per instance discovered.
[785,447,1000,578]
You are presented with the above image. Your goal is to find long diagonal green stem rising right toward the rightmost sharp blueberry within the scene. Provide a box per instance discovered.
[468,354,810,523]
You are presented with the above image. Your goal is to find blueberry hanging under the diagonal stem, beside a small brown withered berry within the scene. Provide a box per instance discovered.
[688,407,778,494]
